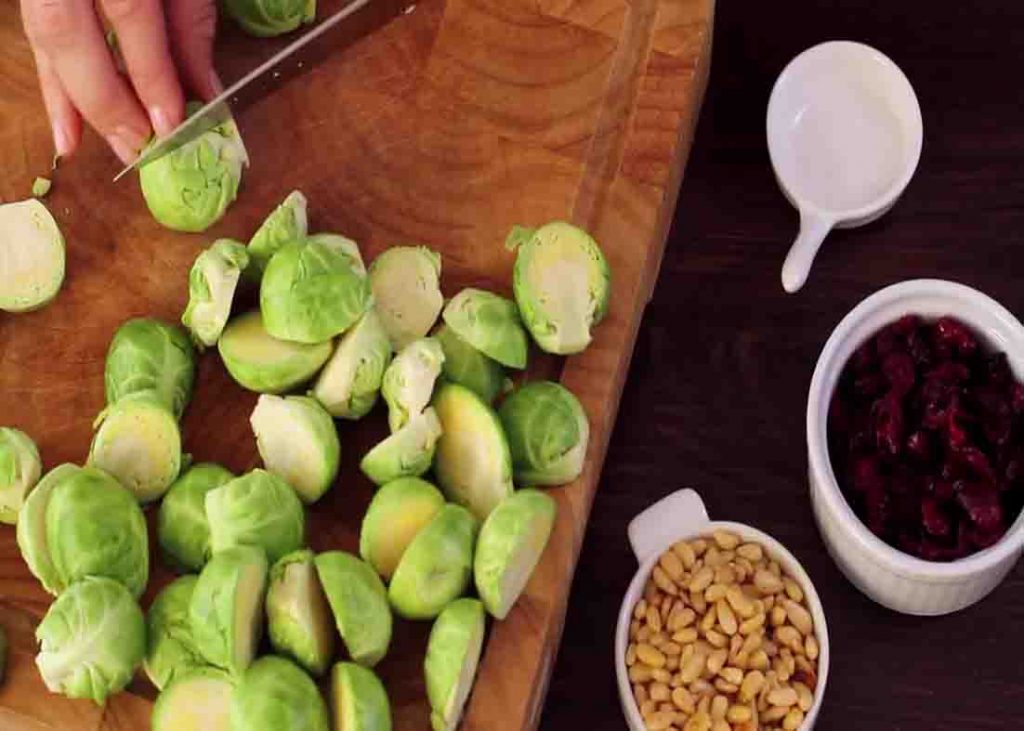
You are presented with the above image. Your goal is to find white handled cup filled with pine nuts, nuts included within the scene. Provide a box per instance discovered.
[615,489,828,731]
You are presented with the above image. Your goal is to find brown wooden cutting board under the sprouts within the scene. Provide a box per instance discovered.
[0,0,714,731]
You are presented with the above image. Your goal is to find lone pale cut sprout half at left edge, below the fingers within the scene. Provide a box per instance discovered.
[0,199,65,312]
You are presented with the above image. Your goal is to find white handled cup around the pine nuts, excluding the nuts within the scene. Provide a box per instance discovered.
[615,489,828,731]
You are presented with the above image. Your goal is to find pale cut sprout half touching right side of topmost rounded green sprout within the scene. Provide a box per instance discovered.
[370,246,444,352]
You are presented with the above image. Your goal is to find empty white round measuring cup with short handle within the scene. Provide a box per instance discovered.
[767,41,923,292]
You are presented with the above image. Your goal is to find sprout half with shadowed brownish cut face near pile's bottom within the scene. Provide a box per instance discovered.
[266,549,334,676]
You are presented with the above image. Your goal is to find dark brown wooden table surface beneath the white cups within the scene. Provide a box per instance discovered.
[541,0,1024,731]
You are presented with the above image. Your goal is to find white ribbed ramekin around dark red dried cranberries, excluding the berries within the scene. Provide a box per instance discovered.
[807,280,1024,615]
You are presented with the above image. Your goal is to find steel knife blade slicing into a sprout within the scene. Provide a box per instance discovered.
[114,0,370,182]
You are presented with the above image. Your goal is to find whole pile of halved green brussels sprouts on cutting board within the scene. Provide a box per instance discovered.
[0,186,608,731]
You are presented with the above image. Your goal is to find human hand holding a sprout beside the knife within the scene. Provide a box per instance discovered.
[20,0,220,165]
